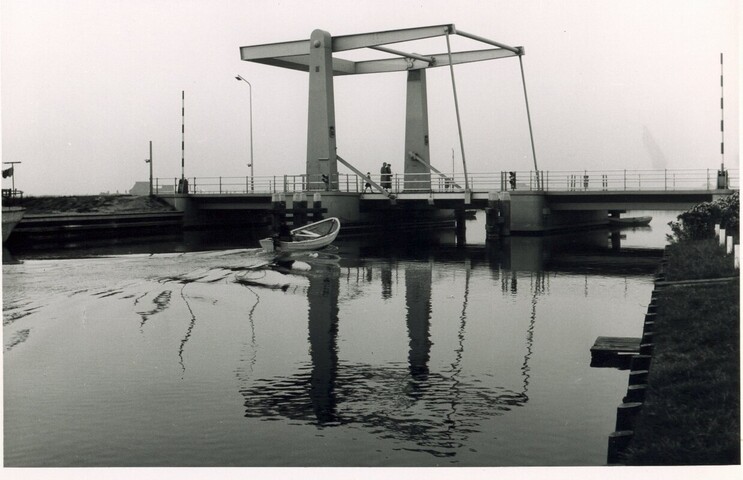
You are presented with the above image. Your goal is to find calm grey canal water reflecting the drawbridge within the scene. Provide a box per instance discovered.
[3,212,675,467]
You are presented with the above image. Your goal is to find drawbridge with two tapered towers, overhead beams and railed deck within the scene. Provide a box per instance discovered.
[156,24,738,238]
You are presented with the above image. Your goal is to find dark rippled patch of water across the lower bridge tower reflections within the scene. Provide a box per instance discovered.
[240,363,528,457]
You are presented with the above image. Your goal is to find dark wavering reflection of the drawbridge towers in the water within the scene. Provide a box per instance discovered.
[234,242,628,457]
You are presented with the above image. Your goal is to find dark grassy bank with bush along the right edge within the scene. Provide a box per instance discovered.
[624,194,741,465]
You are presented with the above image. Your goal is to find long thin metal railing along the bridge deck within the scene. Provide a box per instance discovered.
[153,169,740,195]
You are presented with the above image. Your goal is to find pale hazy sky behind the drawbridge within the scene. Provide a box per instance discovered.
[0,0,740,195]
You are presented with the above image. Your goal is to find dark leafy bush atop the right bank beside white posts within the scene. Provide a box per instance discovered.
[668,192,739,243]
